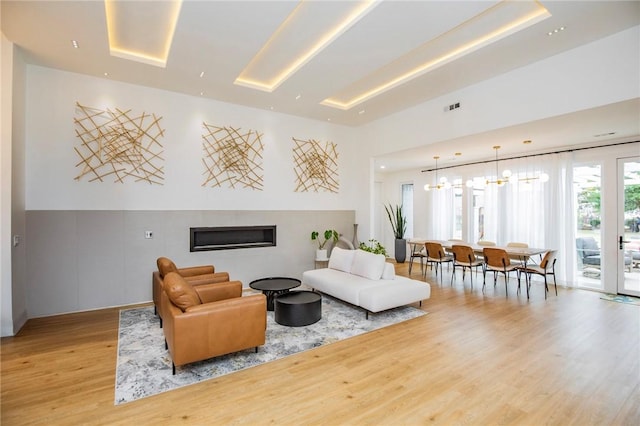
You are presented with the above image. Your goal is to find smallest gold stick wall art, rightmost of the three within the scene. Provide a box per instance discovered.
[293,138,339,192]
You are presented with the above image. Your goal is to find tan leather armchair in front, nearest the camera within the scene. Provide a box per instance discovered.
[161,272,267,374]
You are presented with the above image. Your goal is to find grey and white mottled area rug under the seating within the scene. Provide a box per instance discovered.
[115,295,426,405]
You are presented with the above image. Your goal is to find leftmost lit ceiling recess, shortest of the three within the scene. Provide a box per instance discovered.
[104,0,182,68]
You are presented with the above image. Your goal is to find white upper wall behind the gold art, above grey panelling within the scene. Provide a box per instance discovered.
[26,66,361,210]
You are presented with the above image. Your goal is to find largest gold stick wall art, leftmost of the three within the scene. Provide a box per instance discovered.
[73,102,164,185]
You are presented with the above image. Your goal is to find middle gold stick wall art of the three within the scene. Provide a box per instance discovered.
[202,122,264,191]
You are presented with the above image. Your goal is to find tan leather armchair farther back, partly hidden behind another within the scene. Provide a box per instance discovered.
[151,257,229,327]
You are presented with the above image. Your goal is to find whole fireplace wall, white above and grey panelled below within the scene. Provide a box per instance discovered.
[16,65,369,317]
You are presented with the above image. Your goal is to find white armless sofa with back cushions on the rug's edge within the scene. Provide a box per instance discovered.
[302,247,431,318]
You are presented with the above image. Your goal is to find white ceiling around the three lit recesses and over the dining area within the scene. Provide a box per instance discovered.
[0,0,640,170]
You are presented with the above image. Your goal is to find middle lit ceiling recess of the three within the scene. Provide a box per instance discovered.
[234,0,380,92]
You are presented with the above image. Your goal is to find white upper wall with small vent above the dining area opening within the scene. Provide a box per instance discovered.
[361,26,640,156]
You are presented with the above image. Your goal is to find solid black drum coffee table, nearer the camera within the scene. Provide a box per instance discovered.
[274,290,322,327]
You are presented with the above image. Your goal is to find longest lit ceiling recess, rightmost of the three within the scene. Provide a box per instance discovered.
[321,0,551,110]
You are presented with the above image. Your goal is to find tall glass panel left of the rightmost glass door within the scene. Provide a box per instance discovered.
[573,164,605,289]
